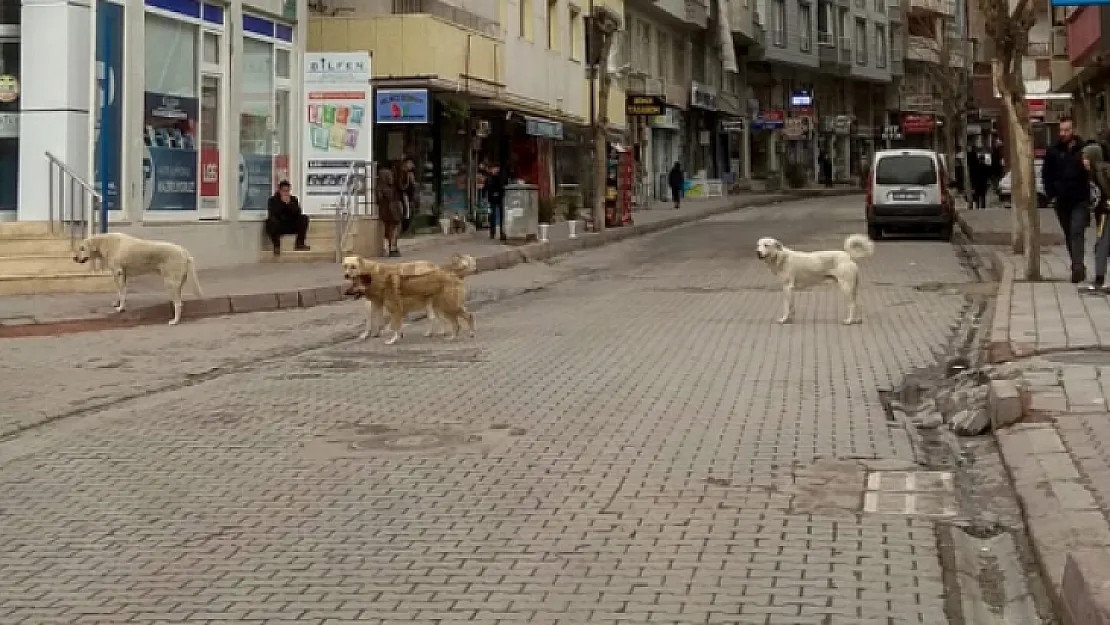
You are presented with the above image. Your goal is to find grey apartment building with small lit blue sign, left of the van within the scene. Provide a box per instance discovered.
[747,0,899,180]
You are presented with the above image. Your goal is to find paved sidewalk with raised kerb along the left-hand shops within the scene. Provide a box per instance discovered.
[0,188,857,331]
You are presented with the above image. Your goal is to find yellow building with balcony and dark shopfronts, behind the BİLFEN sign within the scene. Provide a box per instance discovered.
[309,0,625,219]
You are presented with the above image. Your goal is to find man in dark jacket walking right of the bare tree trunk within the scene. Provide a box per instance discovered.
[1041,118,1091,284]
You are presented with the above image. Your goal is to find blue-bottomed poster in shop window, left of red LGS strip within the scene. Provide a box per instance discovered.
[142,91,199,211]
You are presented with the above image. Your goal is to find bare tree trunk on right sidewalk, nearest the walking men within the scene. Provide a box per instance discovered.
[979,0,1041,280]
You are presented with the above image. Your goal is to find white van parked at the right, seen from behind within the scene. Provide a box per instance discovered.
[866,149,956,240]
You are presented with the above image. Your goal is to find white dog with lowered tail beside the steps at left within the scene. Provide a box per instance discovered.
[73,232,204,325]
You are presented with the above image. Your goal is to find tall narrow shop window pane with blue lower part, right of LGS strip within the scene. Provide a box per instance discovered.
[239,38,276,210]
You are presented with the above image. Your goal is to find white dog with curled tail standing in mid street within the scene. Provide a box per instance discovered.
[756,234,875,325]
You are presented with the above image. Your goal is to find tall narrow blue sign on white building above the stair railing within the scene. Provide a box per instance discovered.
[93,0,123,211]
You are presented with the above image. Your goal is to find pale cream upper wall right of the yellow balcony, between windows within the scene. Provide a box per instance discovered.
[506,0,588,120]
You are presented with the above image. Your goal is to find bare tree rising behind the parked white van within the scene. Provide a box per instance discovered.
[911,18,971,200]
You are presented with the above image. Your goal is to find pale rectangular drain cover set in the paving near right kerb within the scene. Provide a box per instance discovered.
[864,471,958,517]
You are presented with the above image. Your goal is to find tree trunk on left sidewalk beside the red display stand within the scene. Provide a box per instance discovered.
[587,4,620,232]
